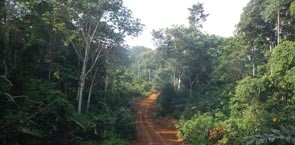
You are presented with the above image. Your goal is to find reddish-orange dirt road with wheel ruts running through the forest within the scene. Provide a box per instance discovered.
[130,93,183,145]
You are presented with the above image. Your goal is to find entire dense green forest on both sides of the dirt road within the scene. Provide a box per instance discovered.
[0,0,295,145]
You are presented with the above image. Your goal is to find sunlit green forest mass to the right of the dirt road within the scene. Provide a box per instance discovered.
[153,0,295,145]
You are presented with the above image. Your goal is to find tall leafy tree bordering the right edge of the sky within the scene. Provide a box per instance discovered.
[237,0,276,76]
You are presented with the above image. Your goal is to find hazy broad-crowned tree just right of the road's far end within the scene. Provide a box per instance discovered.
[155,26,221,96]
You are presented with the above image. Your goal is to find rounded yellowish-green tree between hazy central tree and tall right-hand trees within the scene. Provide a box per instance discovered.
[212,36,252,84]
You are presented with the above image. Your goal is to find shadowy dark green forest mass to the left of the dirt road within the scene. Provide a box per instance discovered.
[0,0,143,145]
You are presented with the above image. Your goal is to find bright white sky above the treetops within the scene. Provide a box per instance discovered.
[124,0,249,49]
